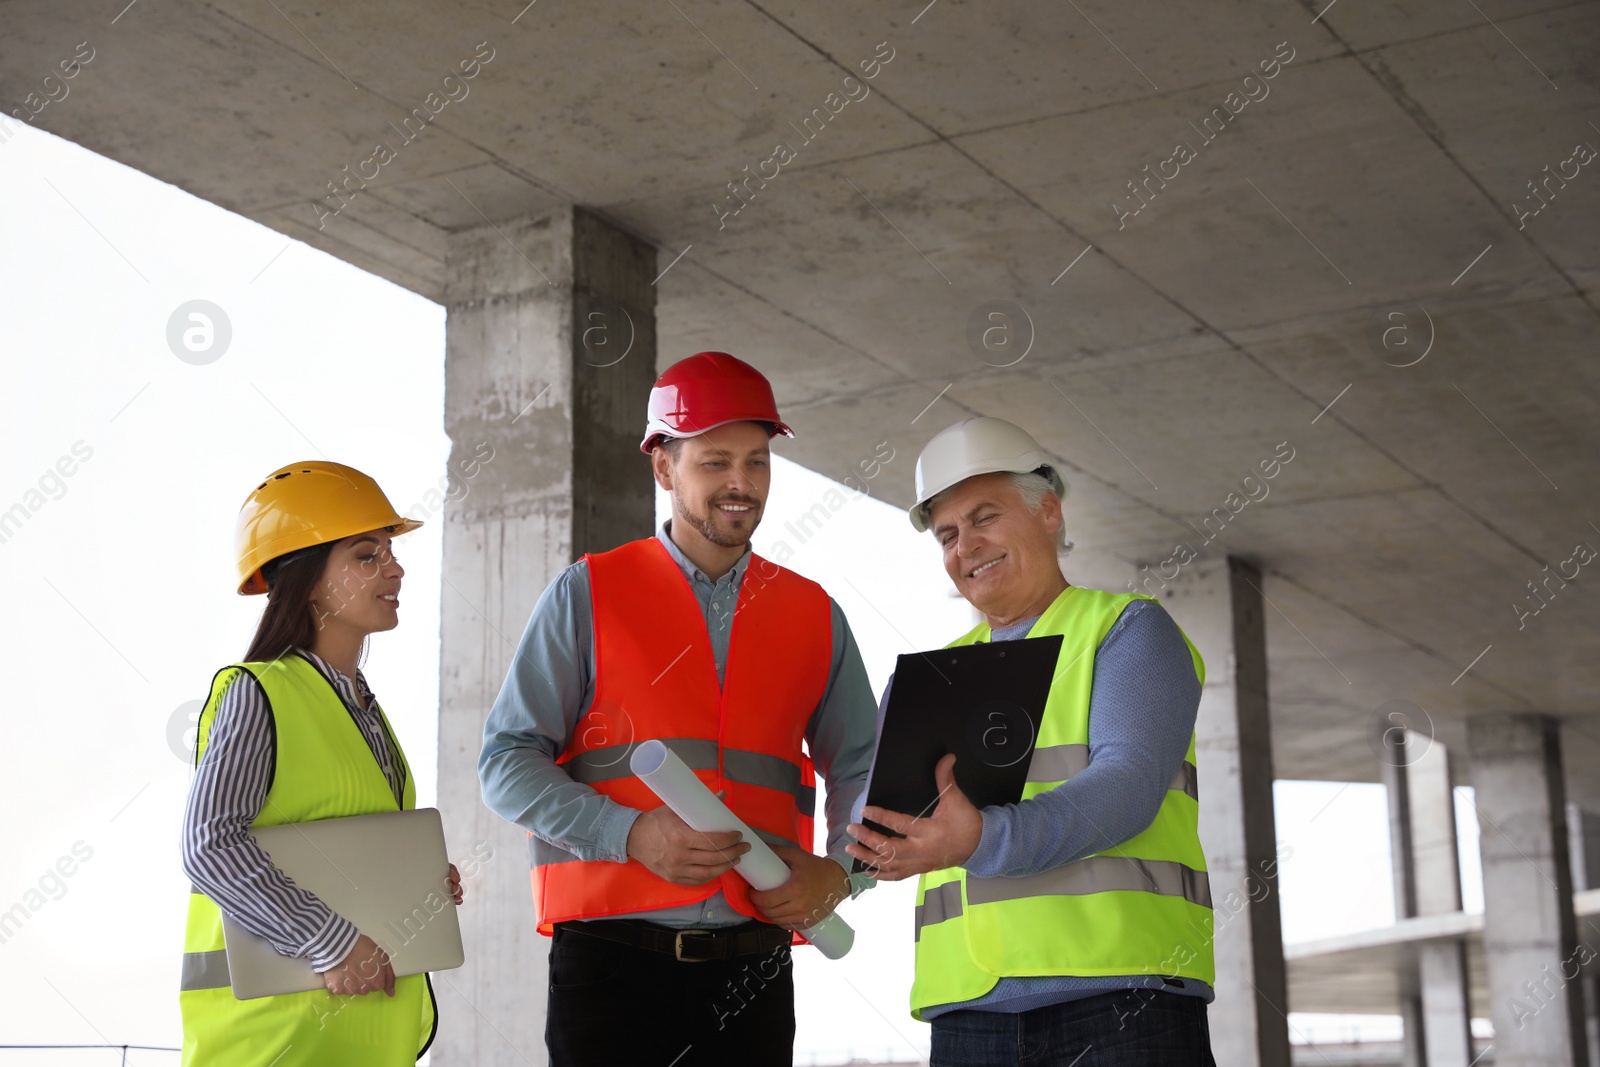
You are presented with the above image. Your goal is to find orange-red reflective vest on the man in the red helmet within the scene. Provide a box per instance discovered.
[528,537,834,934]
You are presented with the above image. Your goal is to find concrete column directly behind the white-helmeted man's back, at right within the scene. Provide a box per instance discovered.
[1160,557,1290,1067]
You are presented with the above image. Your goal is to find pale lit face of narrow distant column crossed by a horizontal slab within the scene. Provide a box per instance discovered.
[1405,733,1474,1067]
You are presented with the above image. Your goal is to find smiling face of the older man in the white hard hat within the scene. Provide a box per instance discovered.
[928,474,1067,627]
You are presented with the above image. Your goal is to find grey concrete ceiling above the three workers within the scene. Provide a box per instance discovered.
[0,0,1600,783]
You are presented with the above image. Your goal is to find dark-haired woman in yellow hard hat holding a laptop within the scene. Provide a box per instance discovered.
[179,461,461,1067]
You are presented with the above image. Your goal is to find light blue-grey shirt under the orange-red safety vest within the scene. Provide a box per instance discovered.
[478,522,875,929]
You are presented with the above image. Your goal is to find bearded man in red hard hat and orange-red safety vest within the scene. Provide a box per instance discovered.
[478,352,877,1067]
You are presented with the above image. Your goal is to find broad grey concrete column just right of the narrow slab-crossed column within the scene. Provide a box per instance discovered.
[1467,715,1594,1067]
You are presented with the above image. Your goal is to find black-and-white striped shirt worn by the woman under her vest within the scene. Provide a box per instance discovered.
[182,649,405,971]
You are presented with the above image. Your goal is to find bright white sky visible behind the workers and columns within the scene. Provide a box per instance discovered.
[0,130,1482,1067]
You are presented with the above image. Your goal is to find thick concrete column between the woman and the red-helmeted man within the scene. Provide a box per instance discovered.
[432,208,656,1067]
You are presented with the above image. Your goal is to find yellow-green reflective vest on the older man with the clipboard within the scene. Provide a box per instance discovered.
[910,585,1216,1019]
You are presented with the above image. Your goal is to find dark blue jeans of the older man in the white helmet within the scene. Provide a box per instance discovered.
[930,989,1216,1067]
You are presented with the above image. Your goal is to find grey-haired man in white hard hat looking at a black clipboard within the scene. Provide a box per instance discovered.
[848,418,1214,1067]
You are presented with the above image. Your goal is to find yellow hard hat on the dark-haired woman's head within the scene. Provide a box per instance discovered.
[234,459,422,597]
